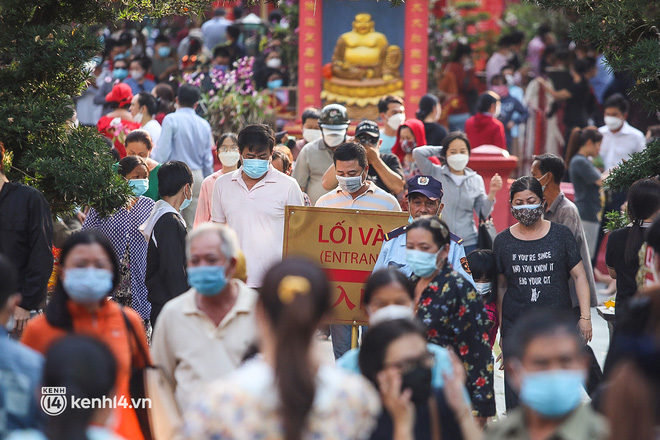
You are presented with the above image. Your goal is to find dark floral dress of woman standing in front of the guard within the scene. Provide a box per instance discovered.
[411,263,495,417]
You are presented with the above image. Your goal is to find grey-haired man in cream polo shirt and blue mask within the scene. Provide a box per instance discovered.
[151,223,258,408]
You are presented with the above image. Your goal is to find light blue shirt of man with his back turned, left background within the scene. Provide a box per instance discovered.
[152,107,213,177]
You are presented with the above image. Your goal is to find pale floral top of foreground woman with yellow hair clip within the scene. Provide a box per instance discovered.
[182,358,381,440]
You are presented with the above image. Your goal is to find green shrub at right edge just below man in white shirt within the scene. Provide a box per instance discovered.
[603,139,660,191]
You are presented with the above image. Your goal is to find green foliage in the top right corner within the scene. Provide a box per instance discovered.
[528,0,660,111]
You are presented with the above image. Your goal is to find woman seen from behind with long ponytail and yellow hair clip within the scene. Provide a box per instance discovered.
[183,259,380,440]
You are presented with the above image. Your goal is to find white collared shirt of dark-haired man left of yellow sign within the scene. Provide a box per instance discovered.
[211,165,304,287]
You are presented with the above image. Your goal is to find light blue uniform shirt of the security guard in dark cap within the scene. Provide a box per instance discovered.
[374,225,476,288]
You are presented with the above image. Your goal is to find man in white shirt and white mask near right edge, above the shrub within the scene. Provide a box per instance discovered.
[598,93,646,171]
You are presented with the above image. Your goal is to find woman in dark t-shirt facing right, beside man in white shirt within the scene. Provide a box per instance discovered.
[566,127,603,259]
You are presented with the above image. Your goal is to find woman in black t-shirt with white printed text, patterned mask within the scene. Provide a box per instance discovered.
[493,176,592,408]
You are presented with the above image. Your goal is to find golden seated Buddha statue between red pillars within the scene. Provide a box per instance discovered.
[321,13,403,112]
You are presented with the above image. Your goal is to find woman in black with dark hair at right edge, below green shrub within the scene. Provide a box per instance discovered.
[605,179,660,317]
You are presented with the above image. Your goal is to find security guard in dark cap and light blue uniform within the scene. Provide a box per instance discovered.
[374,176,476,288]
